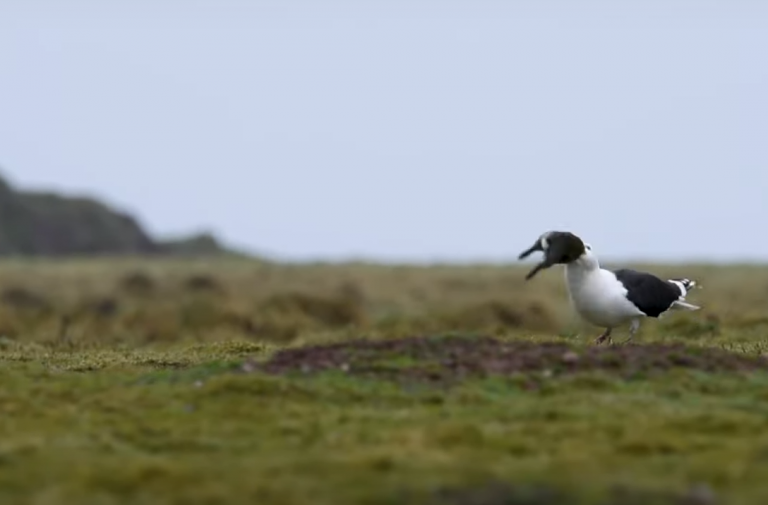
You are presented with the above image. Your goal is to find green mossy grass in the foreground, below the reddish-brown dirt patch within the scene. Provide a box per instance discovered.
[0,336,768,505]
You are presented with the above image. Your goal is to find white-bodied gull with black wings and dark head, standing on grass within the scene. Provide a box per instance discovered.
[519,231,701,344]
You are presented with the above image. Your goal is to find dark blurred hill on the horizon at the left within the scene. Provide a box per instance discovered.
[0,170,242,256]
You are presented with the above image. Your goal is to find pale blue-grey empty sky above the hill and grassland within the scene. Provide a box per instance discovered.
[0,0,768,260]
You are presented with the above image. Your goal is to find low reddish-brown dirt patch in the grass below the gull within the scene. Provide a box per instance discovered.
[255,336,768,382]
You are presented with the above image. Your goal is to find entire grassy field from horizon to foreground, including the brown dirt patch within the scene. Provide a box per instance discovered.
[0,260,768,505]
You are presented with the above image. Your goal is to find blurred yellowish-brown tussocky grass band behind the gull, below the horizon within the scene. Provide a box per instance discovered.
[0,260,768,343]
